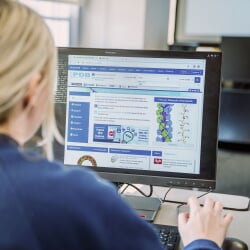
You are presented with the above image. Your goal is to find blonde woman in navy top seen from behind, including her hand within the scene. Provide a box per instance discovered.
[0,0,232,250]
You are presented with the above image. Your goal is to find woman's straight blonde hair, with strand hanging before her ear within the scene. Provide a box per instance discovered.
[0,0,62,159]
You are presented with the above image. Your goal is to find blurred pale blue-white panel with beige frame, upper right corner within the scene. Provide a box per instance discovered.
[174,0,250,45]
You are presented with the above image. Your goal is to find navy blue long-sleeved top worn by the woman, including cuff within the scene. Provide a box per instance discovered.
[0,135,219,250]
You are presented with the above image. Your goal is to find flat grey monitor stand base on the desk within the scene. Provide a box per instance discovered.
[122,195,161,222]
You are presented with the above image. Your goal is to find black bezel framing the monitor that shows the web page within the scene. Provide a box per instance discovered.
[58,48,222,189]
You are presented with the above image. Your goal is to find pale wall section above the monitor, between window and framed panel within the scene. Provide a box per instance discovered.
[80,0,169,49]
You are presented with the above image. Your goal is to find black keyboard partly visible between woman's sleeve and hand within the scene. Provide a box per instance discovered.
[152,224,181,250]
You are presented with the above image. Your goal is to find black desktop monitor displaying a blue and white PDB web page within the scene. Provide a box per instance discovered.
[56,48,221,188]
